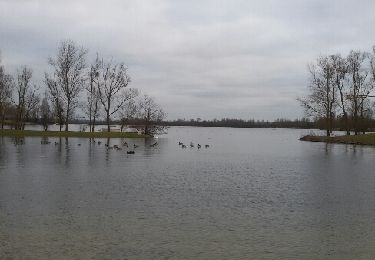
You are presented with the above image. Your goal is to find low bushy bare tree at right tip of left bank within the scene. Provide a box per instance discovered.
[138,95,166,136]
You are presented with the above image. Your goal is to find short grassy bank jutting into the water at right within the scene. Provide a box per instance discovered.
[300,133,375,145]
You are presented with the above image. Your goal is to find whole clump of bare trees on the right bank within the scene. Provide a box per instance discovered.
[298,46,375,136]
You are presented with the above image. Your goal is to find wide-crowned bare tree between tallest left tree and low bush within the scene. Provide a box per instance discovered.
[96,57,138,132]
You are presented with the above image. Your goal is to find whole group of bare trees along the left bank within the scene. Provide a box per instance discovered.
[0,40,166,135]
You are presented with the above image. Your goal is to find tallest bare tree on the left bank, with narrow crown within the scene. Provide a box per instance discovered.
[49,40,87,131]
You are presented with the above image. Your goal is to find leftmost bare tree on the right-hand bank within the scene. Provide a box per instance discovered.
[299,57,337,136]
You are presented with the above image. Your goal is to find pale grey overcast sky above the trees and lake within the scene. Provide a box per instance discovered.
[0,0,375,120]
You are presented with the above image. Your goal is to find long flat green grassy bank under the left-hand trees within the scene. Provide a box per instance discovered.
[0,129,148,138]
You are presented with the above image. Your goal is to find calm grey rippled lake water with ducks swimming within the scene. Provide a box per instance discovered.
[0,127,375,259]
